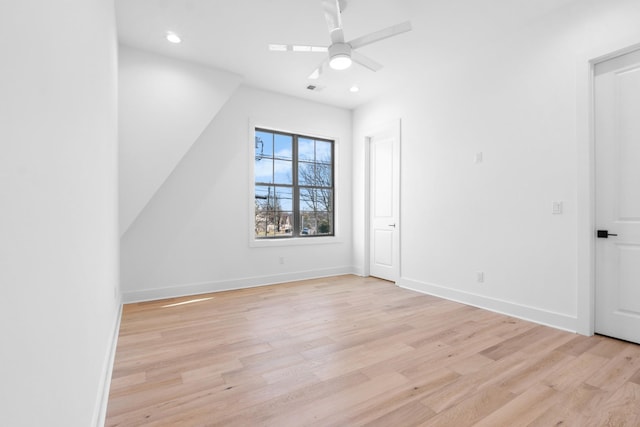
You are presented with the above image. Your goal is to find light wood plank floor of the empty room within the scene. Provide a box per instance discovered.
[106,276,640,427]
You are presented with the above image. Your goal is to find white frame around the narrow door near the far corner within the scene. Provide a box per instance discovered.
[363,119,402,283]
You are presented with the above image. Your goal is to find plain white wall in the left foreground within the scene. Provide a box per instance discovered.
[0,0,119,427]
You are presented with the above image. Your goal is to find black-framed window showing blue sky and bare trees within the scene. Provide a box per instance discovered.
[254,128,335,239]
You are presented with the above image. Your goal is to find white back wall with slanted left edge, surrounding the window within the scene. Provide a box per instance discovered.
[121,87,352,301]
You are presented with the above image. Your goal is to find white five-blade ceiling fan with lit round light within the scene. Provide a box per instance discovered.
[269,0,411,79]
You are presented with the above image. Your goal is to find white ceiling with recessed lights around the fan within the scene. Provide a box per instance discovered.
[116,0,578,108]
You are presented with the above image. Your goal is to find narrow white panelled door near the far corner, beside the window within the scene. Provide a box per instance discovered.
[369,123,400,282]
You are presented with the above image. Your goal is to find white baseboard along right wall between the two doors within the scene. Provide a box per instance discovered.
[397,277,578,332]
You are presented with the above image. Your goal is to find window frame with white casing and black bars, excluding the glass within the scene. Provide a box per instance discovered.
[249,122,341,247]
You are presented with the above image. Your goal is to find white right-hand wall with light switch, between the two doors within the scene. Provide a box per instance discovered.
[354,0,640,333]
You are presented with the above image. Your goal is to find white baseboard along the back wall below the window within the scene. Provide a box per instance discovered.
[122,267,354,304]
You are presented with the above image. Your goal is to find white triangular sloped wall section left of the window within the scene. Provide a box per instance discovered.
[118,45,241,235]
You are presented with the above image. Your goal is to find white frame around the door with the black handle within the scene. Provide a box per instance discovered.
[575,39,640,336]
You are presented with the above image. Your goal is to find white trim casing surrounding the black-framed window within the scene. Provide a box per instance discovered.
[247,118,344,248]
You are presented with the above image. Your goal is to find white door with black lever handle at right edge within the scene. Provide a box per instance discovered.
[594,51,640,343]
